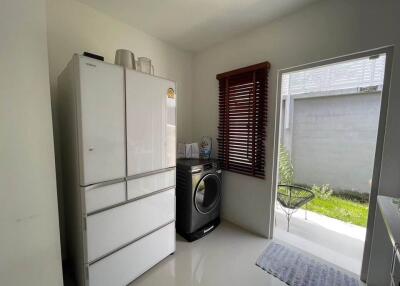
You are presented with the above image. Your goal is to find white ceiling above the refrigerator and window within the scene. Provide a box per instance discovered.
[78,0,317,52]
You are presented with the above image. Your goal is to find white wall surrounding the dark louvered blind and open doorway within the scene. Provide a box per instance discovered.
[193,0,400,255]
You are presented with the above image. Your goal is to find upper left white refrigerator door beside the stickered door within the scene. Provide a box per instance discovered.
[76,57,126,186]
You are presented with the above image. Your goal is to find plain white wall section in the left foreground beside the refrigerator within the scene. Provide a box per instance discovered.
[0,0,62,286]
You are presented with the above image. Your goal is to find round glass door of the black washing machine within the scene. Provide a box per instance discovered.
[194,173,221,214]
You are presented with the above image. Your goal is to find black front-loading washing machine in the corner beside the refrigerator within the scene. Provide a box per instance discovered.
[176,159,222,241]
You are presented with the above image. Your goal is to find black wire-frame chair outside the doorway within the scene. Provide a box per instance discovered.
[277,185,315,232]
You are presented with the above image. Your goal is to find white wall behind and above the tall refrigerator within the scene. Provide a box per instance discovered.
[47,0,192,257]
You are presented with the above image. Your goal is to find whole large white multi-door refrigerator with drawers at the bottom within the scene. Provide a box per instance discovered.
[58,55,176,286]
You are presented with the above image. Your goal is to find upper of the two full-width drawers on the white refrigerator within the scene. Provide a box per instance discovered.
[87,189,175,263]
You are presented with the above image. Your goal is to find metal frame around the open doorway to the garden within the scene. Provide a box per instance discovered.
[268,46,394,281]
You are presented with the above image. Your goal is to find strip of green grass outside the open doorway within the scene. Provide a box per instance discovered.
[303,196,368,227]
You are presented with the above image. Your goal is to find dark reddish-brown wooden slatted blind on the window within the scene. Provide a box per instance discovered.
[217,62,270,178]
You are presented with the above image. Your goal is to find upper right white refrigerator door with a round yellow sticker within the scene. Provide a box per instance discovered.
[125,70,176,176]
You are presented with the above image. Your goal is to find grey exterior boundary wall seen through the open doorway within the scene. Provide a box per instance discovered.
[281,92,381,193]
